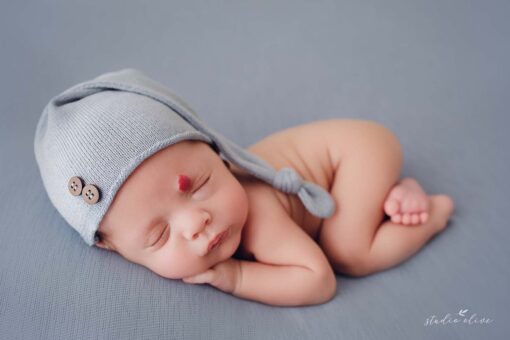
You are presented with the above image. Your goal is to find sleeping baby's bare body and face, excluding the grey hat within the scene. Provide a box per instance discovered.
[96,119,453,305]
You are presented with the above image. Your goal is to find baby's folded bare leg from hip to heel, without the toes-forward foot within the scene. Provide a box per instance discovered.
[319,121,453,276]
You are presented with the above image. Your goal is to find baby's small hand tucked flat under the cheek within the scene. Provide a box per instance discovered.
[182,258,241,294]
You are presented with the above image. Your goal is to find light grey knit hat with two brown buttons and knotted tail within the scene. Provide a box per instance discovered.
[34,69,335,246]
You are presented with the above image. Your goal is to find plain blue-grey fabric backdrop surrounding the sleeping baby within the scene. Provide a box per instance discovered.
[0,0,510,339]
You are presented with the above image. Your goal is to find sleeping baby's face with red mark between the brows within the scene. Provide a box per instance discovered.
[96,141,248,279]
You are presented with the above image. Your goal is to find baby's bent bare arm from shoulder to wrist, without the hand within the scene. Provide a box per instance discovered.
[233,190,336,306]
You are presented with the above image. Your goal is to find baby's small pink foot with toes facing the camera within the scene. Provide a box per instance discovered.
[384,177,429,225]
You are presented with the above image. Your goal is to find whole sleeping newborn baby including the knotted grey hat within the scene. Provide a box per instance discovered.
[34,69,454,306]
